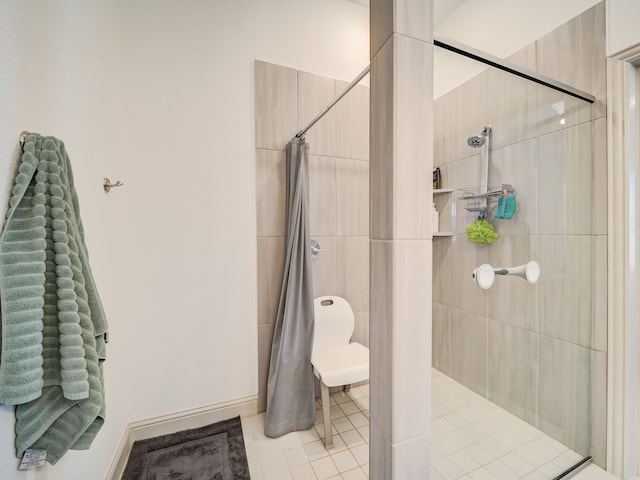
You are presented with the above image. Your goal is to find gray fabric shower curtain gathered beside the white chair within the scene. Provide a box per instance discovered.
[264,137,314,437]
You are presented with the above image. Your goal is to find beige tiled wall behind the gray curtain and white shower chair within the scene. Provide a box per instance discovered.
[255,61,369,411]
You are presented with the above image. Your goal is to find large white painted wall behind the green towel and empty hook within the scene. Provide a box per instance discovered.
[0,0,369,480]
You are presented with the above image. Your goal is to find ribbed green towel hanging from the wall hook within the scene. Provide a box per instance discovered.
[0,134,107,463]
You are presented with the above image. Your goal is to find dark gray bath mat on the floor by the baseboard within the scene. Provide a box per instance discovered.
[122,417,251,480]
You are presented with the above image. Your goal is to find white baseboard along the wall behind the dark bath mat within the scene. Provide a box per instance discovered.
[106,395,258,480]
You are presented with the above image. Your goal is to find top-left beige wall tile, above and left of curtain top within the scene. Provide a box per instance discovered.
[255,61,298,150]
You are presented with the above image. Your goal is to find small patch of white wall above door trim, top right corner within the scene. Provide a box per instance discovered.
[606,0,640,55]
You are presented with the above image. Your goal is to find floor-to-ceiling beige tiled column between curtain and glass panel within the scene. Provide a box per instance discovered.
[370,0,433,480]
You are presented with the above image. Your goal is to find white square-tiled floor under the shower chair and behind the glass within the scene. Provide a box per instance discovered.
[242,370,615,480]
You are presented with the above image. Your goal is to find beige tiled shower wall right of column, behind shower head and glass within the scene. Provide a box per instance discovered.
[433,2,607,465]
